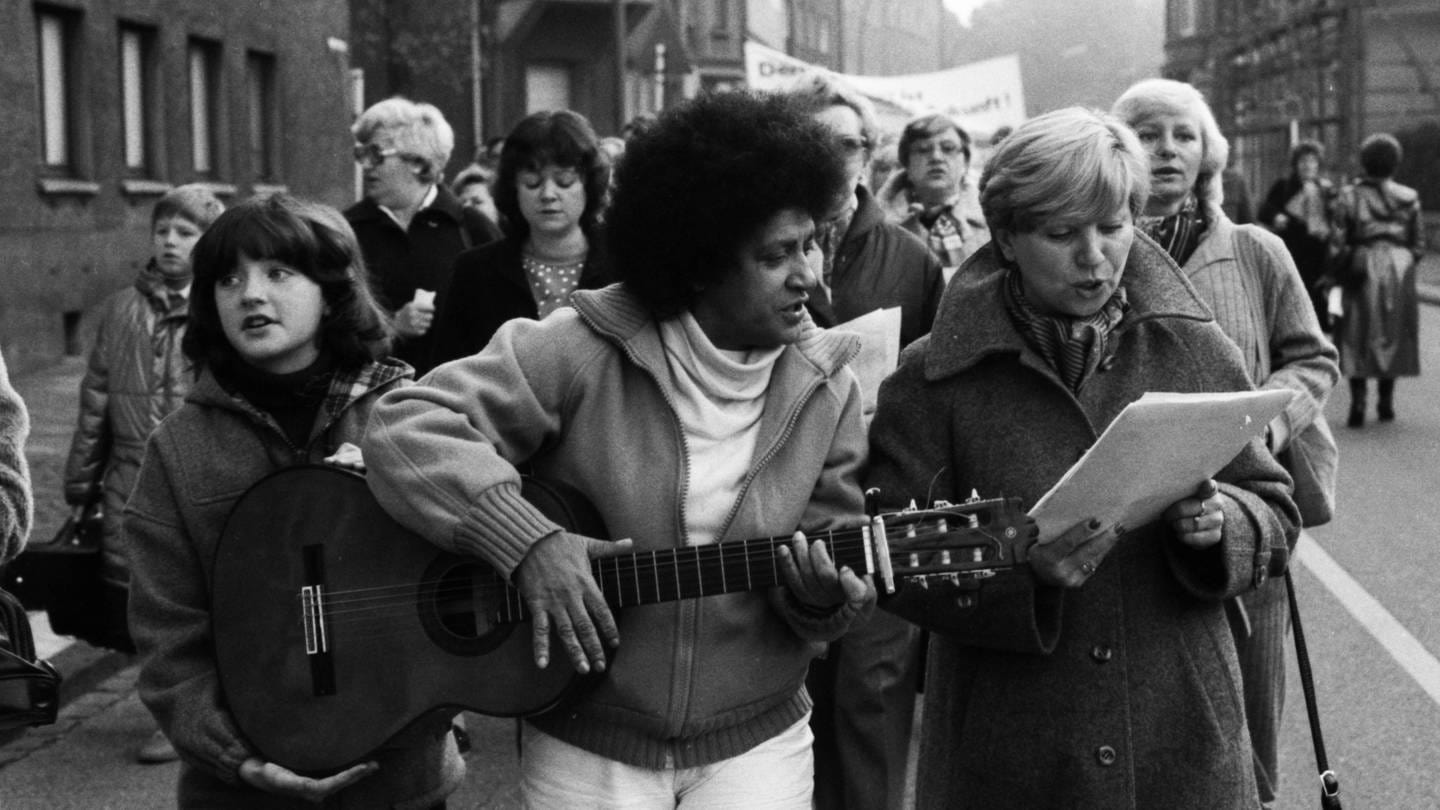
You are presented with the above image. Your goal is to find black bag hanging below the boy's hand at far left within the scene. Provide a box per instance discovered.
[3,506,135,653]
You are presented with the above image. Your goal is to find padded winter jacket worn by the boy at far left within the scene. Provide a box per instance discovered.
[65,262,192,585]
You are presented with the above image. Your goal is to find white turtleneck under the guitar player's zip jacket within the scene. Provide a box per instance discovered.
[660,311,785,545]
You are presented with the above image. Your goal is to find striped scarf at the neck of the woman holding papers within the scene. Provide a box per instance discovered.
[1005,270,1129,393]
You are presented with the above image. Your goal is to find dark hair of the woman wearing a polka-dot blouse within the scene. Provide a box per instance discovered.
[491,110,611,241]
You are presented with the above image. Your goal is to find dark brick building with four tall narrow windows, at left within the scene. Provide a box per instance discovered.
[0,0,353,370]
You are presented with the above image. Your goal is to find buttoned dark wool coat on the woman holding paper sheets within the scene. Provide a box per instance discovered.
[865,233,1299,810]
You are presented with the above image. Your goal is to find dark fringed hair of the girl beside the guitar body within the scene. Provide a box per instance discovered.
[180,193,392,376]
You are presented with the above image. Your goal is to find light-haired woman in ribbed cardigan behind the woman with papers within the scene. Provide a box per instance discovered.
[1112,79,1339,804]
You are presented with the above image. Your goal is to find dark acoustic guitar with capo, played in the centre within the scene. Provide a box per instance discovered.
[210,466,1034,773]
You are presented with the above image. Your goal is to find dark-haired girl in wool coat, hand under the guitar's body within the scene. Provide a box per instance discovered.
[124,195,465,809]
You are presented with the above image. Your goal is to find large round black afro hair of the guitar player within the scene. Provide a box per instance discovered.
[605,92,845,319]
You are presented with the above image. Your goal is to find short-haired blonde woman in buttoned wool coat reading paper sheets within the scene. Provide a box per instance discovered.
[865,108,1297,810]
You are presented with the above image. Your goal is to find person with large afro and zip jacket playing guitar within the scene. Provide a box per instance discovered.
[364,94,876,810]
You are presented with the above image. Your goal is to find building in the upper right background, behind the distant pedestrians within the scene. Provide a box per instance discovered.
[1165,0,1440,212]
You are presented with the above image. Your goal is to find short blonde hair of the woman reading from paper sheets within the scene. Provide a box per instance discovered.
[981,107,1151,233]
